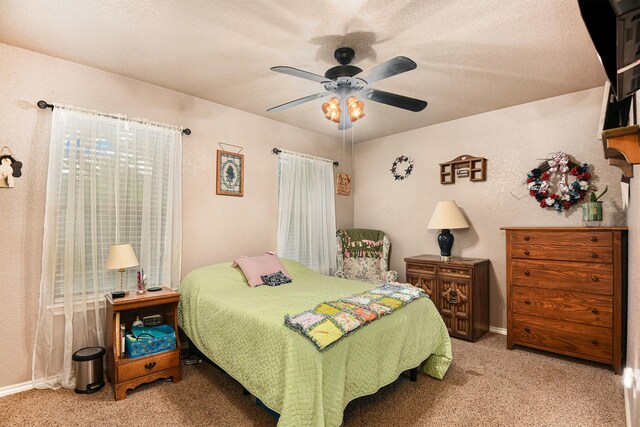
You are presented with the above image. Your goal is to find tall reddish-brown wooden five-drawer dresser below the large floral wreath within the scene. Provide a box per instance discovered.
[503,227,627,374]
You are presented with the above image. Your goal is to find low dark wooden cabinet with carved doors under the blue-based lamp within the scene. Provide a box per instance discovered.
[404,255,489,341]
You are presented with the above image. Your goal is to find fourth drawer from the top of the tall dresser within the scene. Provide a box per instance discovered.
[511,286,613,328]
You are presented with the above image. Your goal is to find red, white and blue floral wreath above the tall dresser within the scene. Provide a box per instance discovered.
[527,151,591,213]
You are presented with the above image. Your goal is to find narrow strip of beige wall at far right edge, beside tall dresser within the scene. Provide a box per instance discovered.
[626,165,640,426]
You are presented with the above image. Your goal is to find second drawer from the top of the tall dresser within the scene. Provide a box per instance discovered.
[511,244,613,263]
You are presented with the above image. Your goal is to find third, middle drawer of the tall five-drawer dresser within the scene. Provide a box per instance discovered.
[511,259,613,295]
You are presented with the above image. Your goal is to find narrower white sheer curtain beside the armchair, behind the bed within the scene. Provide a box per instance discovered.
[278,151,336,274]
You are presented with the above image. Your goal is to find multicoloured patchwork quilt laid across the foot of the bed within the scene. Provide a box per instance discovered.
[284,283,426,351]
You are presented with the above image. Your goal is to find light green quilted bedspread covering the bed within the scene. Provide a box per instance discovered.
[178,260,451,426]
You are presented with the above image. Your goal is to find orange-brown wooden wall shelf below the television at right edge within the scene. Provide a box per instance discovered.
[602,125,640,178]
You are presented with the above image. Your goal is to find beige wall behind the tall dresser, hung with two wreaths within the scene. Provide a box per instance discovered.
[354,88,625,328]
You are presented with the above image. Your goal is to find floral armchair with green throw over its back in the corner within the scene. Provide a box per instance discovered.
[336,228,398,284]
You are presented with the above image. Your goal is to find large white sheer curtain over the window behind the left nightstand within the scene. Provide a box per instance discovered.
[33,105,182,388]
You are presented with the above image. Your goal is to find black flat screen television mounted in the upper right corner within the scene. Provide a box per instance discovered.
[578,0,640,101]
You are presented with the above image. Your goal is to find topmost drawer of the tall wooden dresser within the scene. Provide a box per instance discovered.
[511,231,613,249]
